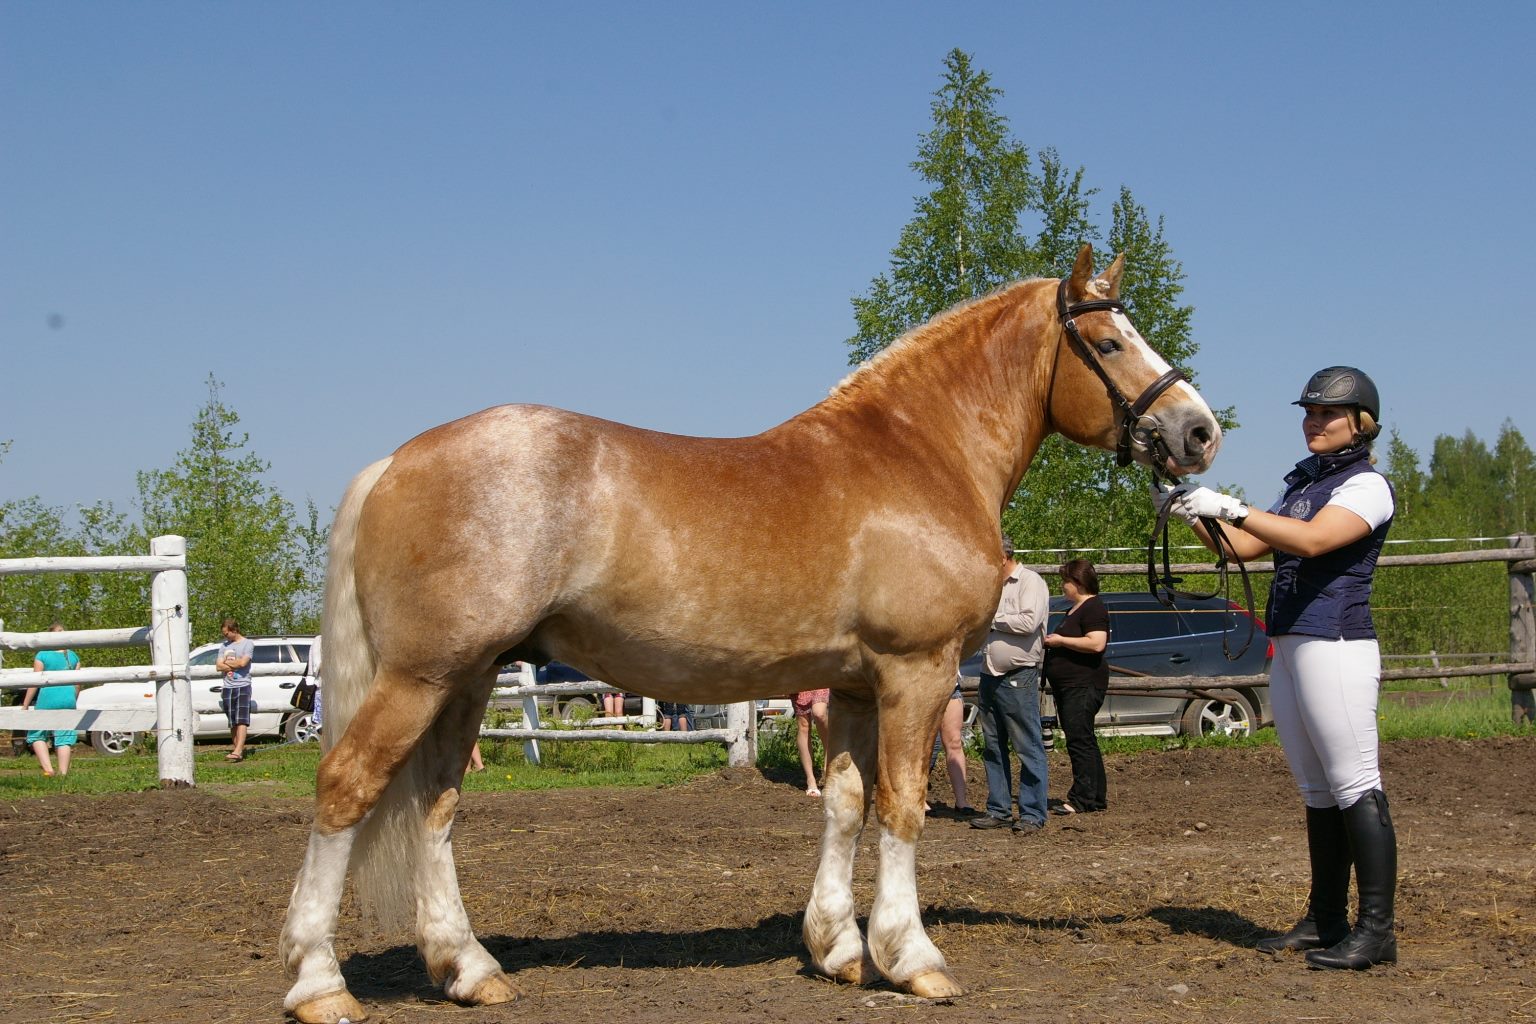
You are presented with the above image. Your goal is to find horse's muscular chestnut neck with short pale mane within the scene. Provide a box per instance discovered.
[806,282,1057,508]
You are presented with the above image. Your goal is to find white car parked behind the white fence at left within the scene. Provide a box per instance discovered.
[77,637,319,754]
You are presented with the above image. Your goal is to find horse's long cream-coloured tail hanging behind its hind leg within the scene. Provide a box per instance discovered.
[321,459,425,929]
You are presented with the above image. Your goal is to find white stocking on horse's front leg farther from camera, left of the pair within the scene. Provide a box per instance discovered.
[800,754,874,984]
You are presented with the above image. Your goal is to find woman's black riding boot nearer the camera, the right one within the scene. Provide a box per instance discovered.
[1307,789,1398,970]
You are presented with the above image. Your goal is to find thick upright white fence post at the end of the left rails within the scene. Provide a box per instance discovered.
[149,534,197,789]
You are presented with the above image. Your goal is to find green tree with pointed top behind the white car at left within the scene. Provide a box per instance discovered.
[138,375,326,643]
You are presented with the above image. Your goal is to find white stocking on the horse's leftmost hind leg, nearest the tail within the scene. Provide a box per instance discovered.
[278,823,362,1021]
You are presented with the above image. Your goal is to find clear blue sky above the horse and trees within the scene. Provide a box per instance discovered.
[0,0,1536,537]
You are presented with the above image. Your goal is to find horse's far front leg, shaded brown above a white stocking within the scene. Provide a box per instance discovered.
[800,692,880,984]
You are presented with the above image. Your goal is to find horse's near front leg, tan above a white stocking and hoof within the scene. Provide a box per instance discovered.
[869,659,965,999]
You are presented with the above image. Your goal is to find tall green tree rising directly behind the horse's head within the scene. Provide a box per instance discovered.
[846,49,1216,561]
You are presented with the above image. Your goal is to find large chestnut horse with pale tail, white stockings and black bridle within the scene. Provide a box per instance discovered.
[283,246,1221,1024]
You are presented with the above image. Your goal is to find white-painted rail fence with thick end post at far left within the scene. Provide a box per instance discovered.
[0,536,195,788]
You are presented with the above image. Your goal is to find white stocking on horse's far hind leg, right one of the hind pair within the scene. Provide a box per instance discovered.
[416,789,522,1004]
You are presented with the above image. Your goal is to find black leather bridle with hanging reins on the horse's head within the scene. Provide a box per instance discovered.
[1057,278,1253,662]
